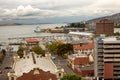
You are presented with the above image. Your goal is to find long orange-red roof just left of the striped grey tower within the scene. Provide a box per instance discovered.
[73,43,94,50]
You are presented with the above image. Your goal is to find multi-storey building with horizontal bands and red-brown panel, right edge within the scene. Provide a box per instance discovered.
[94,36,120,80]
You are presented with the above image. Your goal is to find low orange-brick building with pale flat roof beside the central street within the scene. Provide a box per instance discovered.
[68,54,94,77]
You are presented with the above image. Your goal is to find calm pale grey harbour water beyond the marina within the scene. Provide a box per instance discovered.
[0,24,66,43]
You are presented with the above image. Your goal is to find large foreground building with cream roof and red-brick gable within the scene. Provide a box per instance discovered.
[8,52,64,80]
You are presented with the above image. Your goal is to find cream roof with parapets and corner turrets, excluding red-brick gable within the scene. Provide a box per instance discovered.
[8,52,64,80]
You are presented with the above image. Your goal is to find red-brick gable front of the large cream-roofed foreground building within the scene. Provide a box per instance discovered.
[17,68,57,80]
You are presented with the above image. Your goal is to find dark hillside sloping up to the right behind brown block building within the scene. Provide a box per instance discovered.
[87,13,120,24]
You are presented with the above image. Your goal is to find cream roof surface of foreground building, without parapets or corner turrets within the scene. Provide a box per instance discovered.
[14,53,56,77]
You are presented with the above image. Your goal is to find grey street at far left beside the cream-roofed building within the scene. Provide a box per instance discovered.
[0,52,15,80]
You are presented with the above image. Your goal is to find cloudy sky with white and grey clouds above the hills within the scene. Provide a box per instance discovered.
[0,0,120,23]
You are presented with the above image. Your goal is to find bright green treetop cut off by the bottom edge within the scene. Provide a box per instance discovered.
[60,74,83,80]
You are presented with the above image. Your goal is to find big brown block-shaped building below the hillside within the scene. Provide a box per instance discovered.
[96,19,114,35]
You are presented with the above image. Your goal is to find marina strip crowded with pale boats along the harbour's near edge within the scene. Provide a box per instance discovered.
[0,34,74,45]
